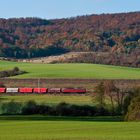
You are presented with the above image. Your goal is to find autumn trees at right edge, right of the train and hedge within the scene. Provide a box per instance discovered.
[95,80,140,121]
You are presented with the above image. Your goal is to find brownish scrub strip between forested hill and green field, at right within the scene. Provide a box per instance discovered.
[52,50,140,67]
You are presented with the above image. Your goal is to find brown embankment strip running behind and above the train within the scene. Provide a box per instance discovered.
[0,78,140,91]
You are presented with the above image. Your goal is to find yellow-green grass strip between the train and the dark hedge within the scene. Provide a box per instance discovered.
[0,95,93,105]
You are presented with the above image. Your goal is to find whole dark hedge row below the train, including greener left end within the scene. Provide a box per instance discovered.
[0,101,117,116]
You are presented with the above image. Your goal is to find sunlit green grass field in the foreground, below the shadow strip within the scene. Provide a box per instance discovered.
[0,117,140,140]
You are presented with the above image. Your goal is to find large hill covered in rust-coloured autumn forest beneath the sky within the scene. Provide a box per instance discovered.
[0,12,140,67]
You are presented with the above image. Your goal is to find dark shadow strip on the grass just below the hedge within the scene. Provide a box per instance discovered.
[0,115,123,122]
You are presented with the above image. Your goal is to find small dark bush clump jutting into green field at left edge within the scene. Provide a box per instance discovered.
[0,67,27,77]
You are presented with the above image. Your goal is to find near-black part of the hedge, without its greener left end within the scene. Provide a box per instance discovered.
[22,101,109,116]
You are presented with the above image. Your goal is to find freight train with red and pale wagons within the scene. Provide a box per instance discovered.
[0,87,86,94]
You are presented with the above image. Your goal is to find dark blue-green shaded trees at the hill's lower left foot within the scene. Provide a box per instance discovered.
[1,46,69,59]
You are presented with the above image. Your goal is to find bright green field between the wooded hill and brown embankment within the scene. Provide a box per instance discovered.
[0,61,140,79]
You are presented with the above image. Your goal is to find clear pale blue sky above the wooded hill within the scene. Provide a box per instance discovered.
[0,0,140,19]
